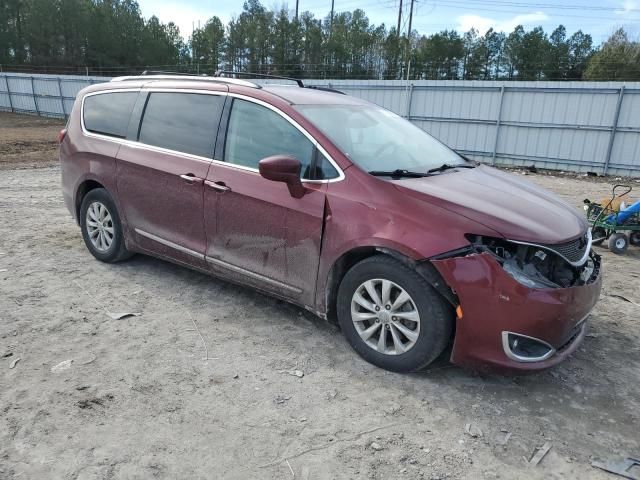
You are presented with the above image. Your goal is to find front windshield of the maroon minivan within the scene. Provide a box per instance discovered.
[295,105,468,172]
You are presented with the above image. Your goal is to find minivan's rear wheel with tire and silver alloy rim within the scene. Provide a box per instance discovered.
[80,188,132,263]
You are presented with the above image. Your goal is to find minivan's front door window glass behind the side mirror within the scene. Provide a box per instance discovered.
[224,99,337,179]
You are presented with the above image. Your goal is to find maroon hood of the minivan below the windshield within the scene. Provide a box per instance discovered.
[393,165,587,244]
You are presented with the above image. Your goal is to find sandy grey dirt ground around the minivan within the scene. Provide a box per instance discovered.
[0,115,640,480]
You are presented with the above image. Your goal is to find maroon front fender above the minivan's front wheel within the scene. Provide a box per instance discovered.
[316,166,498,315]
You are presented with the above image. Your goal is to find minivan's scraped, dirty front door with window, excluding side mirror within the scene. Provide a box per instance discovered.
[205,99,338,305]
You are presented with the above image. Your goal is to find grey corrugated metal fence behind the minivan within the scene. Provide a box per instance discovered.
[0,73,640,176]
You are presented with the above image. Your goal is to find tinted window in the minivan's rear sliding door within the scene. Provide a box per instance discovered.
[138,92,224,158]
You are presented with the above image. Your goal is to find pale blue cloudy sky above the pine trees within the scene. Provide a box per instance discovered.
[138,0,640,43]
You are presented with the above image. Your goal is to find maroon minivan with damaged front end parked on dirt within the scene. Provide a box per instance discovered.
[60,75,602,372]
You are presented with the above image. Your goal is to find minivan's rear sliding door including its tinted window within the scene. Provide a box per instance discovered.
[116,91,225,267]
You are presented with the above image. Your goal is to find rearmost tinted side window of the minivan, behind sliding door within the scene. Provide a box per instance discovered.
[82,92,138,138]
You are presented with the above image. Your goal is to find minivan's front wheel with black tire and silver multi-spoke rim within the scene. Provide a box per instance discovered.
[336,255,454,372]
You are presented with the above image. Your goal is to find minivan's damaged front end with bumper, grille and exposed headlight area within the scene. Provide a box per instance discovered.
[430,232,602,371]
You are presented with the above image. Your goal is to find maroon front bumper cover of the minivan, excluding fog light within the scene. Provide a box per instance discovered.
[432,253,602,372]
